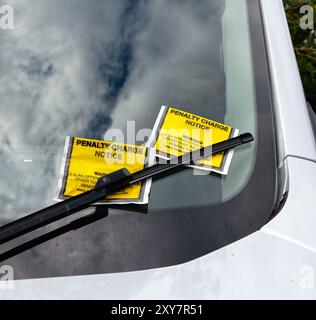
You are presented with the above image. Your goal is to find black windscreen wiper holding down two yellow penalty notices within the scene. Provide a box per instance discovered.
[0,133,254,245]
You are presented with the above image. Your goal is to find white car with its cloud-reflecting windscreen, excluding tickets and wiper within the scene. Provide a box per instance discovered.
[0,0,316,300]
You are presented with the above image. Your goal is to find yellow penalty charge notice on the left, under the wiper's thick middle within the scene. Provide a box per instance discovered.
[57,137,153,204]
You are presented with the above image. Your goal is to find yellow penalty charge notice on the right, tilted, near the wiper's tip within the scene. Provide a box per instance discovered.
[151,106,239,175]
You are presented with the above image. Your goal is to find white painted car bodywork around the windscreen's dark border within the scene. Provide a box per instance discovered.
[0,0,316,299]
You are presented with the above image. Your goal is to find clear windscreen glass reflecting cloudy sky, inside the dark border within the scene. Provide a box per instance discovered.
[0,0,257,221]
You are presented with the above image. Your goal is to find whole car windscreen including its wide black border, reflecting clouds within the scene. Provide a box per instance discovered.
[0,0,275,278]
